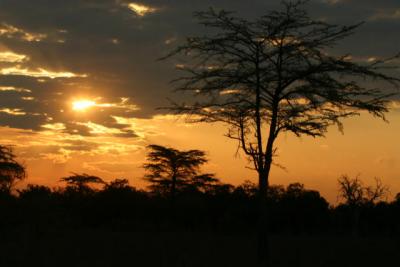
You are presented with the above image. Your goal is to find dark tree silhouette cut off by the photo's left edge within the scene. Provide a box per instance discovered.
[0,145,26,194]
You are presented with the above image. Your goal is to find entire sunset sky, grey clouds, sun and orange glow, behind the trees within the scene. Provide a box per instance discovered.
[0,0,400,203]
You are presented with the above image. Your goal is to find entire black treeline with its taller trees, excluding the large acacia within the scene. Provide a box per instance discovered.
[0,145,400,235]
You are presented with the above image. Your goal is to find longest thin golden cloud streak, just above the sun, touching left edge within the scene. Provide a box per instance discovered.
[0,66,88,79]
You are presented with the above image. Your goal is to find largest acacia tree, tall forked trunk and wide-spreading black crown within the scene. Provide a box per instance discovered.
[163,1,399,263]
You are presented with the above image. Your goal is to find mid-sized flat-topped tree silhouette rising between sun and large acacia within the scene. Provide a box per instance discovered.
[143,145,209,200]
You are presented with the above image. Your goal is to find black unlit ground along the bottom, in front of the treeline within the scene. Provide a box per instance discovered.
[0,229,400,267]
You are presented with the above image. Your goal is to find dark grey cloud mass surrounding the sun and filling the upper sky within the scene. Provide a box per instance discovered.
[0,0,400,134]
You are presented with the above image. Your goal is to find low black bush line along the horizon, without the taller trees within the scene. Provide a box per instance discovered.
[0,180,400,235]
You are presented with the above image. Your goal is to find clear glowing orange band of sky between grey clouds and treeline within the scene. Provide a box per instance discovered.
[0,104,400,203]
